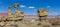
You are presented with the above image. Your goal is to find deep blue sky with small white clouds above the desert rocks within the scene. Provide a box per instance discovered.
[0,0,60,15]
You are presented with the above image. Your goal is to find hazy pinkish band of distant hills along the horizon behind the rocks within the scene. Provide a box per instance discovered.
[0,12,60,19]
